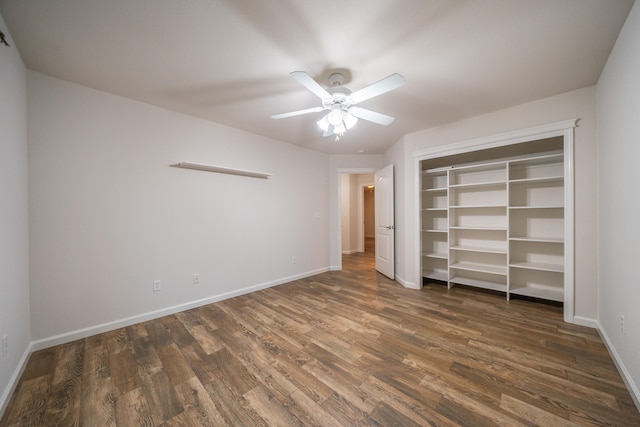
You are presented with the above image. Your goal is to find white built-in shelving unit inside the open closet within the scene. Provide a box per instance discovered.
[421,150,565,302]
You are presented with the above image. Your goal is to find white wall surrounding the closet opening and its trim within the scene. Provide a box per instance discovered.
[396,87,597,323]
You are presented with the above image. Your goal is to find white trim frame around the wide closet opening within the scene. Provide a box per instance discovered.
[413,119,579,323]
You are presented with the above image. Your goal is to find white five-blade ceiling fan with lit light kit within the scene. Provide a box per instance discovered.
[271,71,405,141]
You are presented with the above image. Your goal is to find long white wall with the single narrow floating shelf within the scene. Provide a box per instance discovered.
[27,72,329,347]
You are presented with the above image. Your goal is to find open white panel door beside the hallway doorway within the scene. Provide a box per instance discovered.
[375,165,395,279]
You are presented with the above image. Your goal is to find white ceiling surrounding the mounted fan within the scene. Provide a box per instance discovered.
[0,0,633,154]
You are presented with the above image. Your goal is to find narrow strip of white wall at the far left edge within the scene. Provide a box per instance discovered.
[0,16,31,416]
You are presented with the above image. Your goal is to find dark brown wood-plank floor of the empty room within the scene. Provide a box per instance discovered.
[0,242,640,426]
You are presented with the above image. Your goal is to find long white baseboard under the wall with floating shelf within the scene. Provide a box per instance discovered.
[31,267,329,351]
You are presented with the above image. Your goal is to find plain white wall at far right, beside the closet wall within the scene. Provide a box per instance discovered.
[597,2,640,407]
